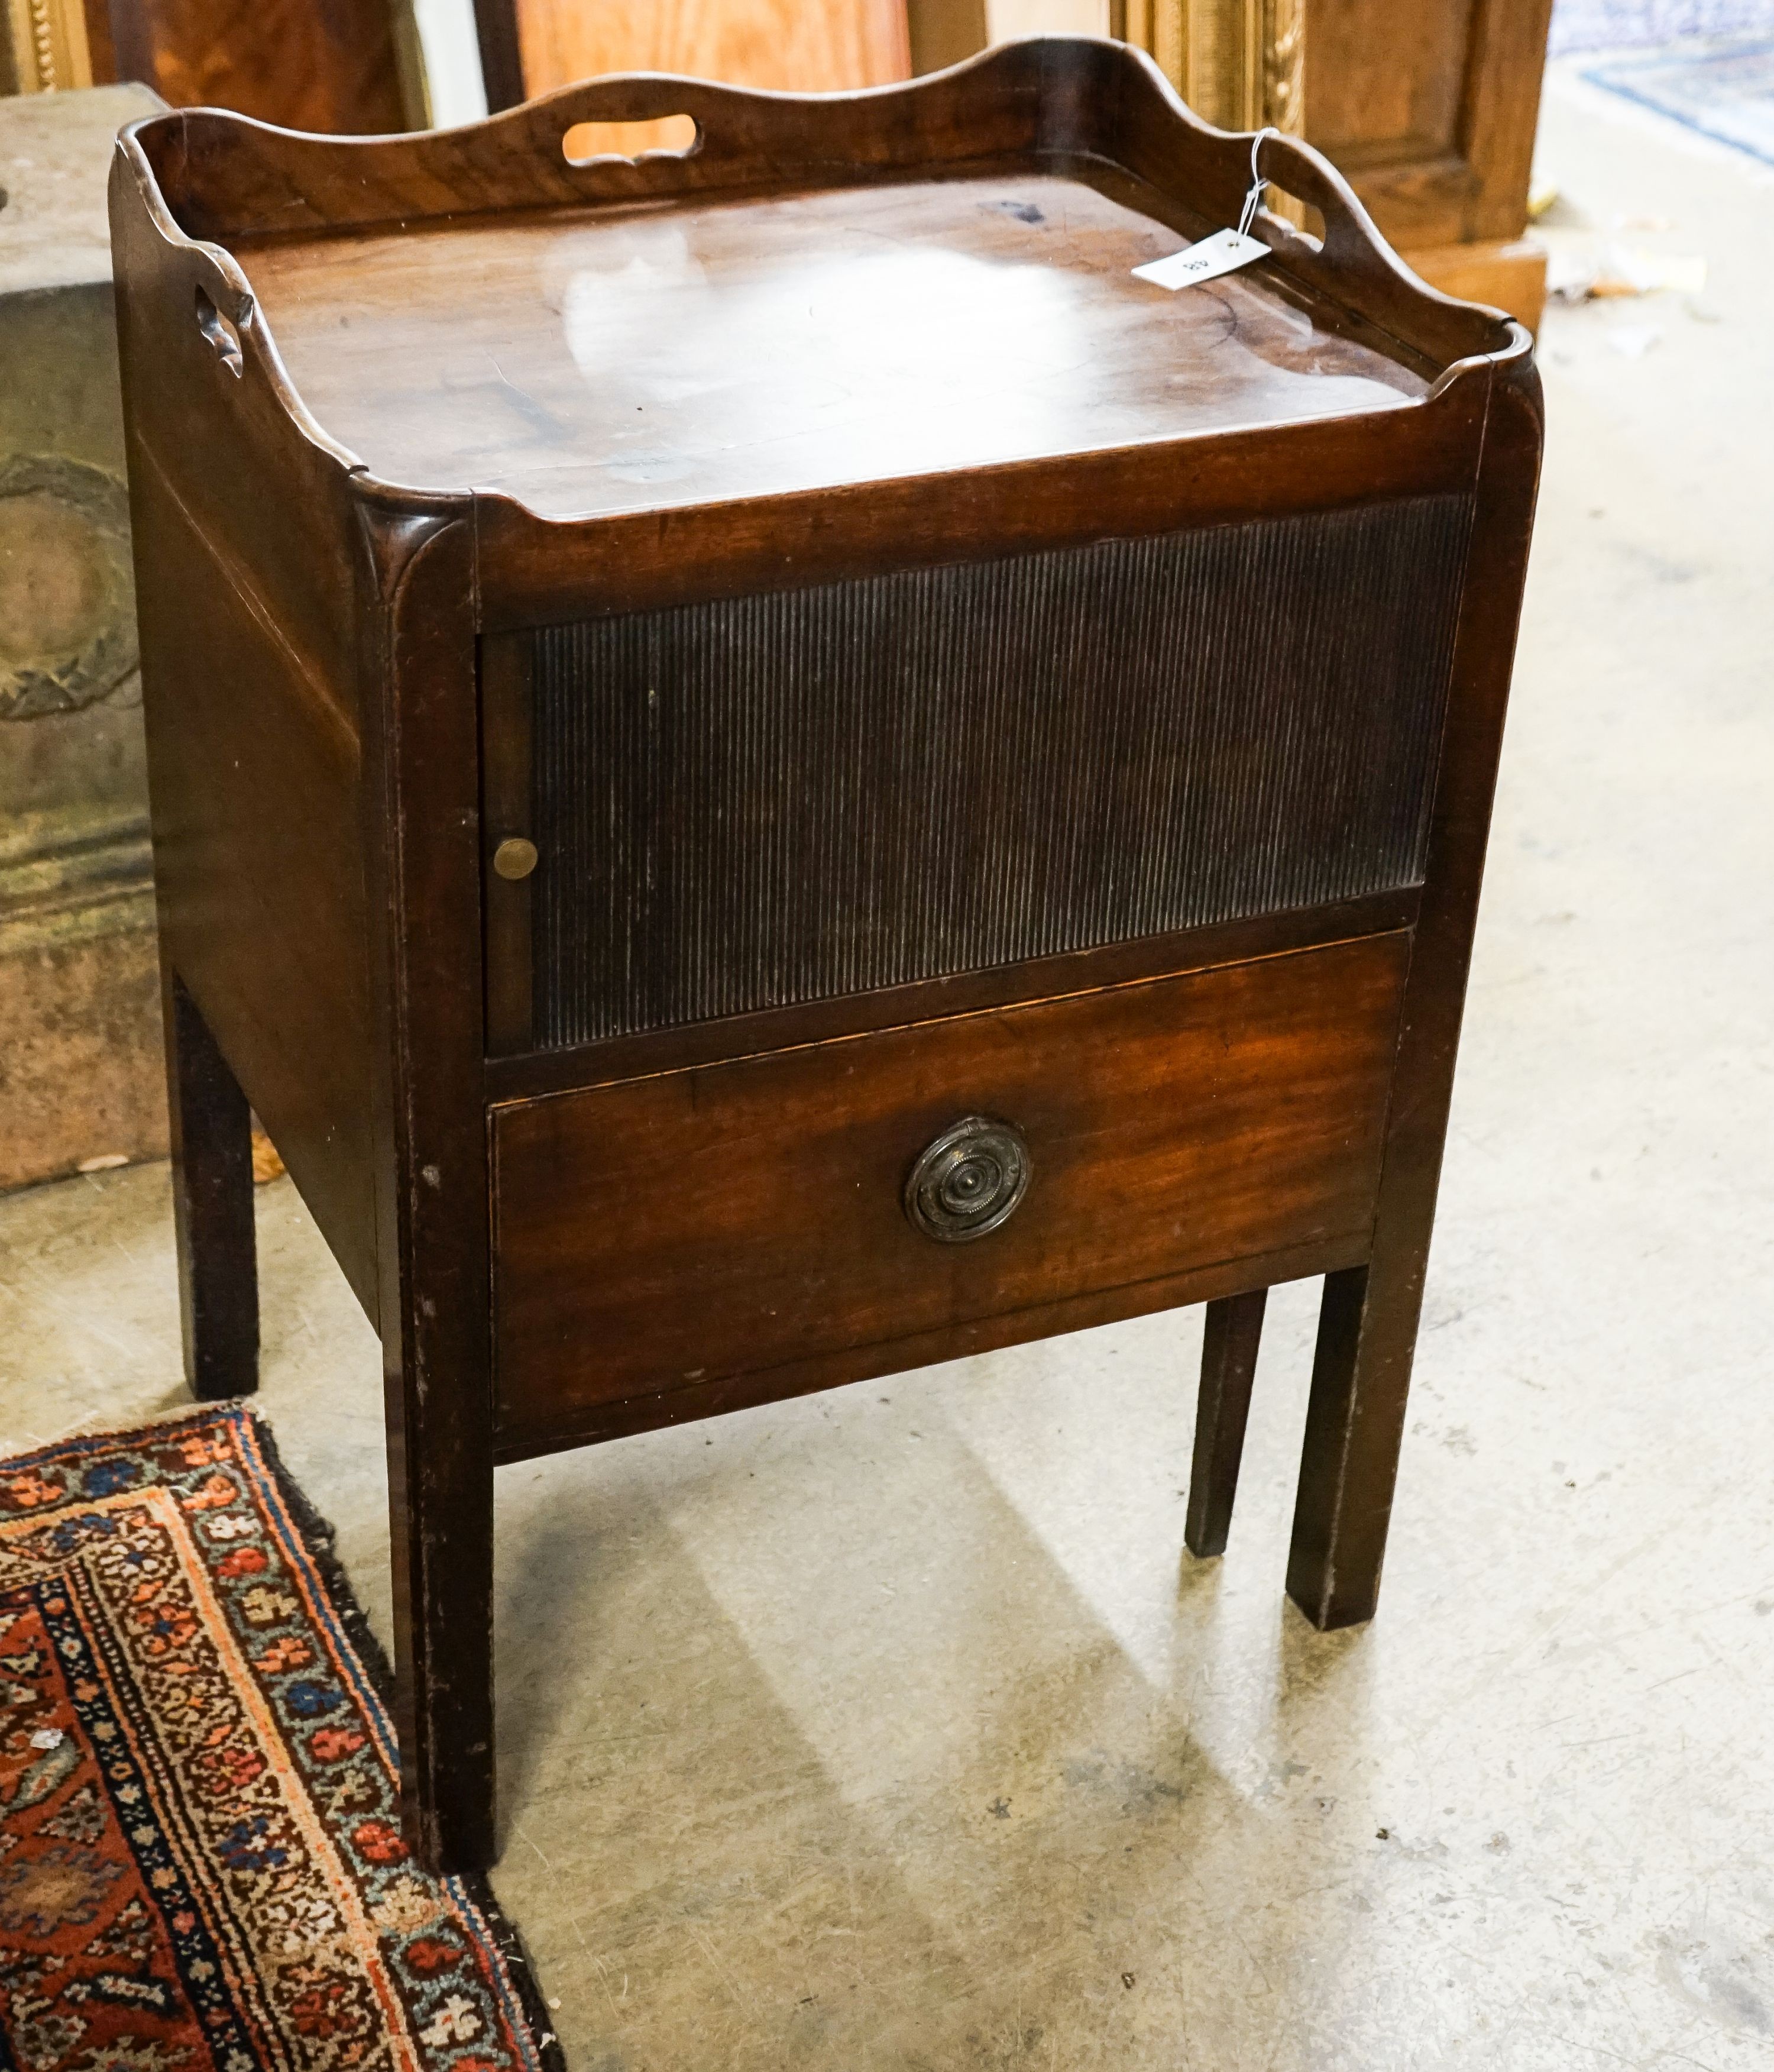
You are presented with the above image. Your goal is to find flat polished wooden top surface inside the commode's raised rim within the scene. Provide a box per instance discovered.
[241,176,1428,518]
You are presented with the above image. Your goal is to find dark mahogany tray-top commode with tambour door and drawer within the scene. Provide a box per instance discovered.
[112,40,1540,1867]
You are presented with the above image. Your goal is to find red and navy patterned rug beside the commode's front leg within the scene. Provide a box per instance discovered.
[0,1405,559,2072]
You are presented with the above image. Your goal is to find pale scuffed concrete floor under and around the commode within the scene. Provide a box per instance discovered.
[0,64,1774,2072]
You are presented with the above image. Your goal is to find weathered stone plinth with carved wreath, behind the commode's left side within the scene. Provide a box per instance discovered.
[0,87,166,1187]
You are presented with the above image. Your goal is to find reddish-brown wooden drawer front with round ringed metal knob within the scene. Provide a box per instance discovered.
[491,932,1409,1453]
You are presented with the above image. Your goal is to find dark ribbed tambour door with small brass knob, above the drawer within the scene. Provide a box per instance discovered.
[485,493,1471,1053]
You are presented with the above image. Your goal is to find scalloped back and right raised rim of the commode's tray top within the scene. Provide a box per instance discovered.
[131,37,1504,379]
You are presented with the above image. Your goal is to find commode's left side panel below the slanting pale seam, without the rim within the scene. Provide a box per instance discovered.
[135,466,375,1318]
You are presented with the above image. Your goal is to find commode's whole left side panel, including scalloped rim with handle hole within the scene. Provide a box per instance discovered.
[112,161,375,1315]
